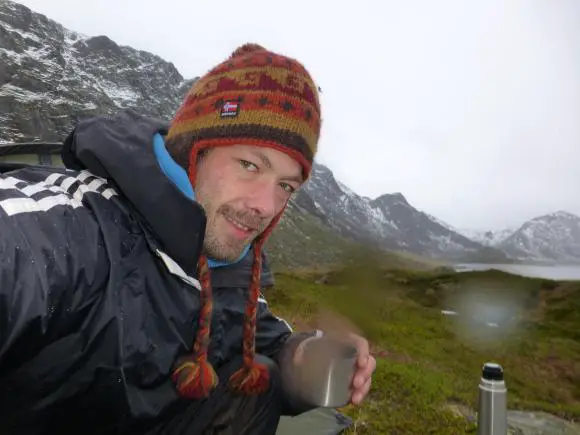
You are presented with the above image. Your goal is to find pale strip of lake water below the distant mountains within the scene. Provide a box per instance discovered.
[454,263,580,280]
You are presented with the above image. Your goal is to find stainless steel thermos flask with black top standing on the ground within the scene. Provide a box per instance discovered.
[477,363,508,435]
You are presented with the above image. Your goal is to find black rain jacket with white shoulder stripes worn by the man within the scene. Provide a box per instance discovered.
[0,111,314,434]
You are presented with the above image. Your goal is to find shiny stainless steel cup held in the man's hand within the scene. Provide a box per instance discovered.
[294,336,357,408]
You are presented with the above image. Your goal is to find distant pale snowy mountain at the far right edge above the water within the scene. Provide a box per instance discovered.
[497,211,580,263]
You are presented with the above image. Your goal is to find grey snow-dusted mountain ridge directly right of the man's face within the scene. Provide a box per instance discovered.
[298,164,503,260]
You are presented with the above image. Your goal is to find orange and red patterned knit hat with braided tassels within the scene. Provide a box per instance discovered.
[167,44,321,399]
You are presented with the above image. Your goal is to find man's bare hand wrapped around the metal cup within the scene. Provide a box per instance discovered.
[294,332,377,405]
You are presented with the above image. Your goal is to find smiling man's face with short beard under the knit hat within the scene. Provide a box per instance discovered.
[195,145,302,261]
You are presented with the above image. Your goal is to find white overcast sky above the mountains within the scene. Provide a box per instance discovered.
[11,0,580,229]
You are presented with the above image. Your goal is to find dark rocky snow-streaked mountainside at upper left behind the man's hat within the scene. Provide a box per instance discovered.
[0,0,196,143]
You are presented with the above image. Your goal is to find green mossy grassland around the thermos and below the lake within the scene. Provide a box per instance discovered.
[266,262,580,434]
